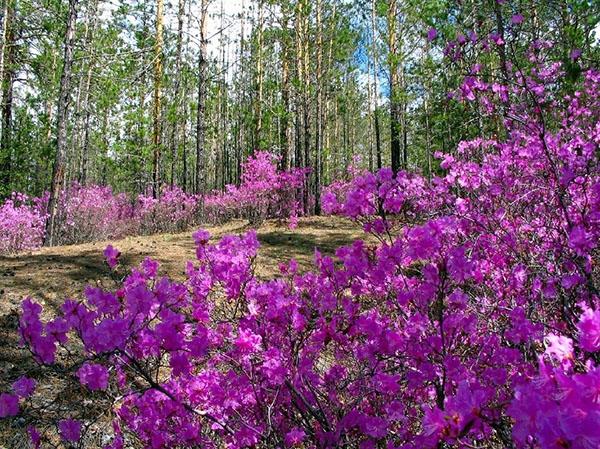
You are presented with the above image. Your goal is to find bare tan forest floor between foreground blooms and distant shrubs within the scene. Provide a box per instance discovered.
[0,217,365,449]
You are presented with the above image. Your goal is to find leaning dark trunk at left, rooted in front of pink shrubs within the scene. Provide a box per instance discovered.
[44,0,79,246]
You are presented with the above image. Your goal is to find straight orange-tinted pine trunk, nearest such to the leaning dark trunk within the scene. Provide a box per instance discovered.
[152,0,164,198]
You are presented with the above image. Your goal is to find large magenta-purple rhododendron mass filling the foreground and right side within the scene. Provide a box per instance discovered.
[0,64,600,449]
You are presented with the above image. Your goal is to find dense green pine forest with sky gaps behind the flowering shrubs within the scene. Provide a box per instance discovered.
[0,0,600,207]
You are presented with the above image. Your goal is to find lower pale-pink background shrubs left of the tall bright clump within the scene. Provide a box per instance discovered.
[0,183,198,253]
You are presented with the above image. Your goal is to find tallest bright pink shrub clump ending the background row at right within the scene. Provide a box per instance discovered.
[204,151,307,224]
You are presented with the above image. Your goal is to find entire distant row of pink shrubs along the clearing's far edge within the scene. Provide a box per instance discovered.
[0,152,306,253]
